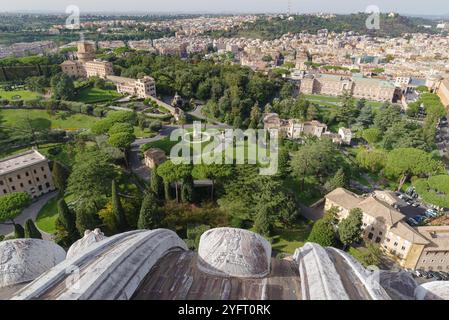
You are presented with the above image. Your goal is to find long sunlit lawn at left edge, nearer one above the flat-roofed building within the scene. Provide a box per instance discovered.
[0,110,99,130]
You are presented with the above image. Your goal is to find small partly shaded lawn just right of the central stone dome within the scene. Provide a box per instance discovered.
[272,221,312,254]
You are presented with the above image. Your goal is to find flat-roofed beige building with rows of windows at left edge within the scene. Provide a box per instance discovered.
[0,150,55,198]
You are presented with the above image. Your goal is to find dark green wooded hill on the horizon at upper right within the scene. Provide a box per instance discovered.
[209,13,436,40]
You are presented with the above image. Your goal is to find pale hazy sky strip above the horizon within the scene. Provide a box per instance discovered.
[0,0,449,14]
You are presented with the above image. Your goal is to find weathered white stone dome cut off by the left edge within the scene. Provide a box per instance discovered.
[0,239,66,288]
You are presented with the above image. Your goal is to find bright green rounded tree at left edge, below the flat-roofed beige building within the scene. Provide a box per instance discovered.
[0,192,31,225]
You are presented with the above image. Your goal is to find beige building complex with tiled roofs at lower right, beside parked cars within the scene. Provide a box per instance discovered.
[325,188,449,271]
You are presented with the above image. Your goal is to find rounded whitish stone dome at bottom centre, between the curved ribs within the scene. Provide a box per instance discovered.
[198,228,271,278]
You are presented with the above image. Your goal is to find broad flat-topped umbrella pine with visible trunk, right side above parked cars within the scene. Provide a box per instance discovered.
[385,148,444,191]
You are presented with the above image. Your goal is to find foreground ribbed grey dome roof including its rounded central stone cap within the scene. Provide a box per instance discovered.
[0,228,449,300]
